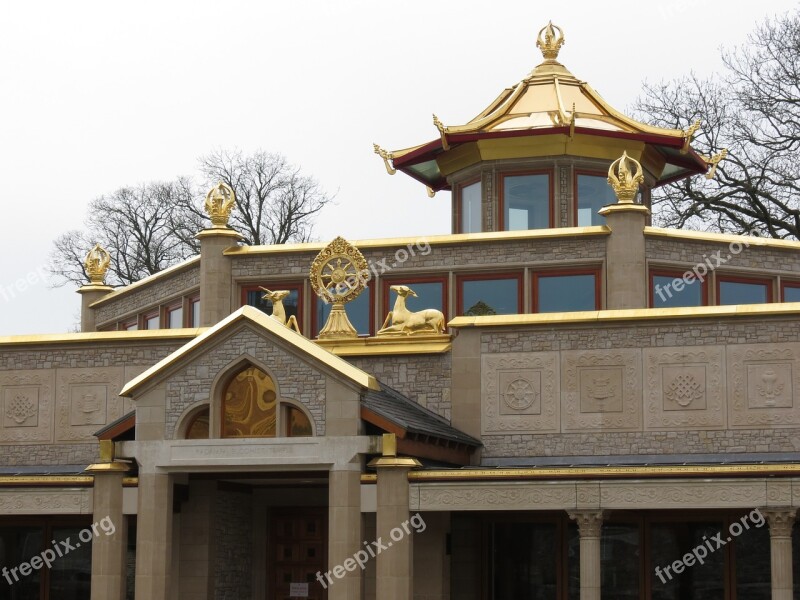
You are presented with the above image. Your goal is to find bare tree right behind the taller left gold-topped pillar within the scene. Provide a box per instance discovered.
[200,150,333,245]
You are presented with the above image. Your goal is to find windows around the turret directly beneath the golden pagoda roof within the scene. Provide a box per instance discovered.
[456,170,617,233]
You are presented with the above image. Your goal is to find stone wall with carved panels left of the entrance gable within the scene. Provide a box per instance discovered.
[0,340,184,466]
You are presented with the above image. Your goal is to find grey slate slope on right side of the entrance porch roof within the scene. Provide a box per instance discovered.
[361,383,482,447]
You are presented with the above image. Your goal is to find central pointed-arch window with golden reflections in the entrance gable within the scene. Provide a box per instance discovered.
[222,367,278,437]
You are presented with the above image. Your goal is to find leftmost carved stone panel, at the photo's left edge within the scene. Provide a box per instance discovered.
[0,370,54,444]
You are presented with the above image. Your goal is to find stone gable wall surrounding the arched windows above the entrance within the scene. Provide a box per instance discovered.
[166,327,326,439]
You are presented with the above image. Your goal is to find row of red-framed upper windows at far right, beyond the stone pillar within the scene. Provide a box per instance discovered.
[650,269,800,308]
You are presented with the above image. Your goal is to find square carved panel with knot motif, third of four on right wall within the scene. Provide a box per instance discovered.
[644,346,726,430]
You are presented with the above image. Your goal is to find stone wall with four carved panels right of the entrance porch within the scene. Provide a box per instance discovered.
[481,317,800,458]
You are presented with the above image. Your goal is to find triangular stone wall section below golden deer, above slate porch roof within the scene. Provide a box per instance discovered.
[347,353,452,419]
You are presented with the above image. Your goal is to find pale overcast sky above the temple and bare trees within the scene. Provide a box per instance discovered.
[0,0,797,336]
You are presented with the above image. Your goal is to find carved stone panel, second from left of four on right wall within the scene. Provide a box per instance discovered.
[561,349,642,431]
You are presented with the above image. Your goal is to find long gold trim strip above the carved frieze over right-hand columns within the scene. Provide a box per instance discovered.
[361,463,800,484]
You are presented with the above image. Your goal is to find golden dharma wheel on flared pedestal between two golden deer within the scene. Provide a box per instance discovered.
[310,237,369,339]
